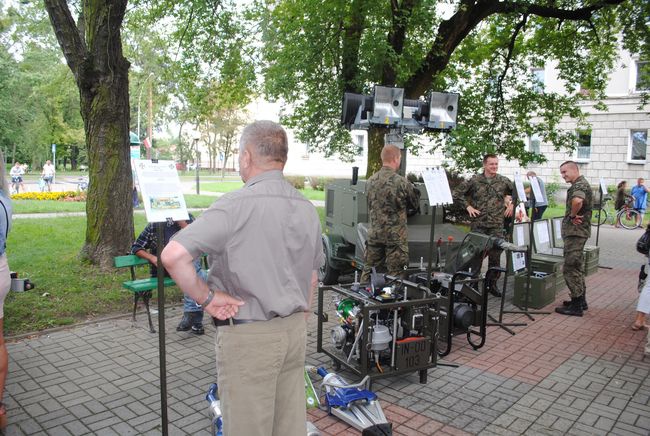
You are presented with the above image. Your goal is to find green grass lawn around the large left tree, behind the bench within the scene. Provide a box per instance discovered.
[4,215,187,335]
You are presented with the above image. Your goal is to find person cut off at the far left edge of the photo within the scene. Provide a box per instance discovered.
[0,151,11,429]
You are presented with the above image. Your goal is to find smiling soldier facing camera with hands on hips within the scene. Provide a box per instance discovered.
[453,154,513,297]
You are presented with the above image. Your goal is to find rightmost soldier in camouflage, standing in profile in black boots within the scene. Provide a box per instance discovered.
[555,161,592,316]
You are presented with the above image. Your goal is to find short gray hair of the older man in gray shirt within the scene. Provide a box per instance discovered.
[239,120,289,164]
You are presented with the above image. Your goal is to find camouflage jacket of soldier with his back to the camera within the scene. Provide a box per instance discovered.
[366,167,418,243]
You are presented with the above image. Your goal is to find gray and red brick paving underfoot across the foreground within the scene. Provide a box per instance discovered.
[5,228,650,435]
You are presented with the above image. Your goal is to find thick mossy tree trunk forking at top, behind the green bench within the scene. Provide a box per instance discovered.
[44,0,134,268]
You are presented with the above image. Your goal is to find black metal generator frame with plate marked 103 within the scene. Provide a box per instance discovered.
[316,280,442,383]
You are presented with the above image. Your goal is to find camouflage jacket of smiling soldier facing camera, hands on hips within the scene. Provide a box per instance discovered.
[453,173,514,229]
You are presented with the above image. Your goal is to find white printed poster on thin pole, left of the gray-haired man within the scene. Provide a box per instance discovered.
[133,159,189,223]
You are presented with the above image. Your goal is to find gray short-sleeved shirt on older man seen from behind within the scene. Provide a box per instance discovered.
[174,171,323,320]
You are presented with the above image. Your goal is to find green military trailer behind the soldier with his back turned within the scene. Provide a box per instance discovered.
[319,175,465,285]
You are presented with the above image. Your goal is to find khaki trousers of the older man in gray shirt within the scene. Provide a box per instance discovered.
[216,313,307,436]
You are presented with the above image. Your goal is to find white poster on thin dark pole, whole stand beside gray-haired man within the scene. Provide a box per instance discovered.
[133,159,189,436]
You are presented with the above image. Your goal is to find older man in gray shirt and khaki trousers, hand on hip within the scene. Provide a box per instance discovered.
[162,121,323,436]
